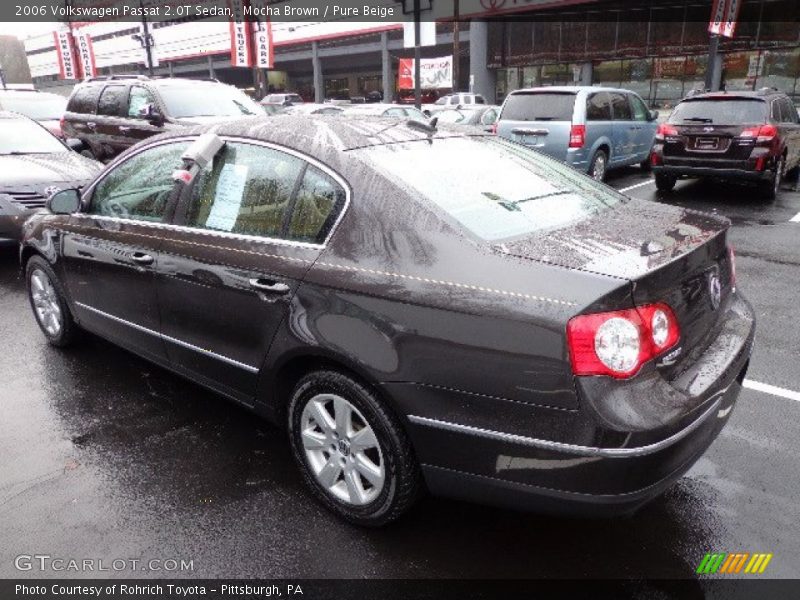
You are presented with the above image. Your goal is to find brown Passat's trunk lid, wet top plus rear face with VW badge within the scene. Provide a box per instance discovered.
[500,199,732,368]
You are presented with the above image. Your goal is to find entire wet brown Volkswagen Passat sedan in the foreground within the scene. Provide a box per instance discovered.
[21,116,754,525]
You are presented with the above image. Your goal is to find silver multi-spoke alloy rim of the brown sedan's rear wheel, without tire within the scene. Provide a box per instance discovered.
[300,394,386,506]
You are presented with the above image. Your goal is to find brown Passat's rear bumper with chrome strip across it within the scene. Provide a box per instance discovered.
[394,297,755,516]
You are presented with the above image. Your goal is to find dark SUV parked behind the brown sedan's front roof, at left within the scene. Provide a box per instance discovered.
[62,75,264,160]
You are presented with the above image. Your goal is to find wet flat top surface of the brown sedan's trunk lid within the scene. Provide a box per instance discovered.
[499,199,730,280]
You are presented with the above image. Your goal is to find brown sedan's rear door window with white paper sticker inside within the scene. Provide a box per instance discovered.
[186,143,303,238]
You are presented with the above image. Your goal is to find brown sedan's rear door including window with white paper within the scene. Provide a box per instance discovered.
[157,140,346,404]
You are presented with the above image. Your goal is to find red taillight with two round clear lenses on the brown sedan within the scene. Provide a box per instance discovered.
[567,303,680,379]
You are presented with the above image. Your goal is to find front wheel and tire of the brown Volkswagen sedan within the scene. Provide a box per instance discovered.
[25,256,78,348]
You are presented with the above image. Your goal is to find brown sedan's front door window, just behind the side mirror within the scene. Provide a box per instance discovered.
[88,142,188,222]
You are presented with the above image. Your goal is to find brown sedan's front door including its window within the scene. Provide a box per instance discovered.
[61,142,187,362]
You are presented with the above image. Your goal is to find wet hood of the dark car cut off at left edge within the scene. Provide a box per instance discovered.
[0,152,103,189]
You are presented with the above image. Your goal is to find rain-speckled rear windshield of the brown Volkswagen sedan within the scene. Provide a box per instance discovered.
[362,136,623,242]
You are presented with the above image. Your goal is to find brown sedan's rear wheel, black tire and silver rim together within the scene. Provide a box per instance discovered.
[288,370,422,527]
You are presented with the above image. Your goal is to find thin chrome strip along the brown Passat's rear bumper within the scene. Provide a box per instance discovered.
[408,388,728,458]
